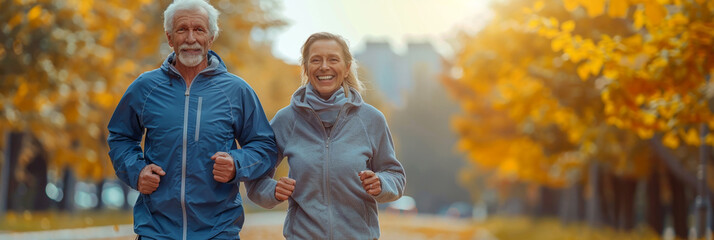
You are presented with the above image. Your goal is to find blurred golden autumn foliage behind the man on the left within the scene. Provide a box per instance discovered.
[0,0,299,212]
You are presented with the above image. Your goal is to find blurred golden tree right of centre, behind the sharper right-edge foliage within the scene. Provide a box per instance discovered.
[445,1,672,232]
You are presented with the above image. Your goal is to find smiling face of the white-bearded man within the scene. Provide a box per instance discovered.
[166,10,213,67]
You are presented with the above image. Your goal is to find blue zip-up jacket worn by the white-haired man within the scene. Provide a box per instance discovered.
[107,51,276,239]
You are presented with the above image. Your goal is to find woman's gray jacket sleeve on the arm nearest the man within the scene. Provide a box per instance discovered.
[245,109,287,209]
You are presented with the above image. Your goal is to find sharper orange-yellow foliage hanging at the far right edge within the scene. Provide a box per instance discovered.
[530,0,714,236]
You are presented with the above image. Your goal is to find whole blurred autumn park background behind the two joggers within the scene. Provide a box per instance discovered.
[0,0,714,239]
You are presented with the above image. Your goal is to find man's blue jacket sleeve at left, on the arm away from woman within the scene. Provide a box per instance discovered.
[107,81,146,189]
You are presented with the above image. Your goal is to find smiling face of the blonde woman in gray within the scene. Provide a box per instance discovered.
[306,40,350,99]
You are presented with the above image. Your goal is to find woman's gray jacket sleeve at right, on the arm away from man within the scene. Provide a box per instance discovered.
[370,114,407,203]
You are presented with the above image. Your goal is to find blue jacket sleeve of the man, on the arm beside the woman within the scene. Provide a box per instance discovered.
[230,86,277,183]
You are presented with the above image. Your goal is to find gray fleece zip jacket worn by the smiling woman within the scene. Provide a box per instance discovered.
[246,86,406,239]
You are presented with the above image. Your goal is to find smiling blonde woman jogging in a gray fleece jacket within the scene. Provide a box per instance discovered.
[247,32,406,239]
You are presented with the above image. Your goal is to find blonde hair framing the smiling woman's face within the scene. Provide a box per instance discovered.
[300,32,364,97]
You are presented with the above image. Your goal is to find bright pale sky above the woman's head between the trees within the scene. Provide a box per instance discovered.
[273,0,490,63]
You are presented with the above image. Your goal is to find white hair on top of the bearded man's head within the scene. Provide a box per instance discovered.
[164,0,220,39]
